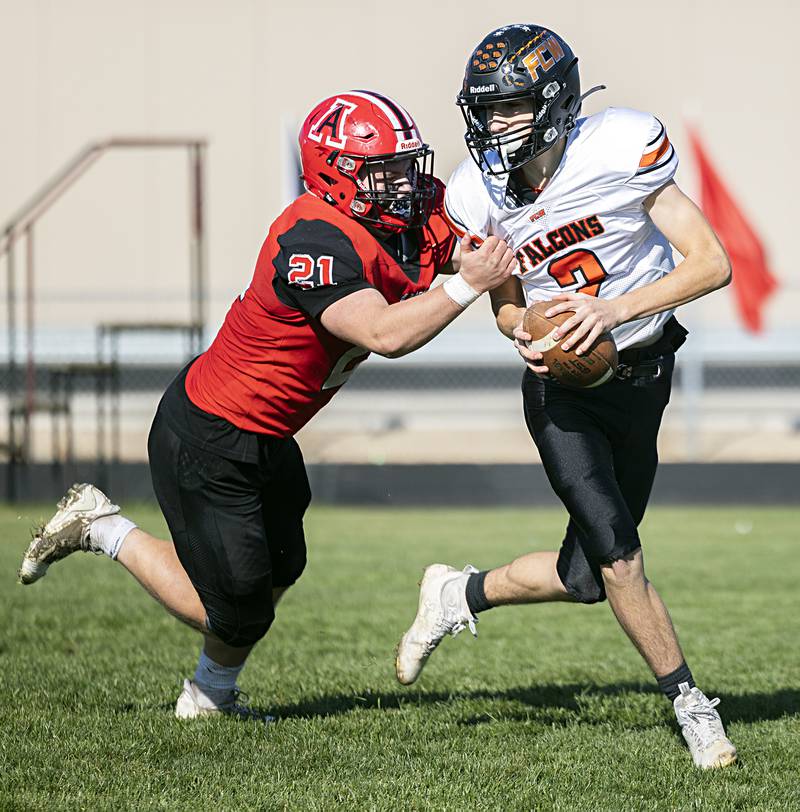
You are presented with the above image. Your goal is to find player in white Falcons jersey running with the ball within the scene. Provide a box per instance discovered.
[396,25,736,768]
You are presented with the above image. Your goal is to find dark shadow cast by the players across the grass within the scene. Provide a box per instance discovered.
[268,682,800,728]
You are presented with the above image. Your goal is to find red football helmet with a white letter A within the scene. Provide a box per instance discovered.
[299,90,436,231]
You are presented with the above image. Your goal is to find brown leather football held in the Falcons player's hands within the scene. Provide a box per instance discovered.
[522,302,618,389]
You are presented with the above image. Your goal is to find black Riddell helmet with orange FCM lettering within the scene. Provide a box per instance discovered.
[456,24,602,175]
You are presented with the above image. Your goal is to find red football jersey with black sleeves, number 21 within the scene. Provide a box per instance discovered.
[186,181,455,437]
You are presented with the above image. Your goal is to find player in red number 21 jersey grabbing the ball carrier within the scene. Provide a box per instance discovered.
[20,91,516,718]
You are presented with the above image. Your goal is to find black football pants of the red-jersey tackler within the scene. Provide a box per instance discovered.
[148,411,311,646]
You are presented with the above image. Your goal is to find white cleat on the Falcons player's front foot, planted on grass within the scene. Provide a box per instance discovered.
[673,682,736,770]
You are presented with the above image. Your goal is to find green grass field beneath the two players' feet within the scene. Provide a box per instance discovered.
[0,506,800,810]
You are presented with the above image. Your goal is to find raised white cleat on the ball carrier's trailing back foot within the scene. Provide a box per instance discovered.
[395,564,478,685]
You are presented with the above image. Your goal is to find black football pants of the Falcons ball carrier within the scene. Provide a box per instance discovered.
[522,353,675,603]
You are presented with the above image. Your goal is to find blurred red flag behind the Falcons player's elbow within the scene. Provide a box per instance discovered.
[689,128,777,333]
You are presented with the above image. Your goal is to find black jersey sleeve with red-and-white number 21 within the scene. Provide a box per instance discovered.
[272,220,372,318]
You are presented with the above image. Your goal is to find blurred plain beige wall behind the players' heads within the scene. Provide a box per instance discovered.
[0,0,800,338]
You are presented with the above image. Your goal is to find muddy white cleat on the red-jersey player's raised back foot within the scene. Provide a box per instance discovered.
[18,483,119,584]
